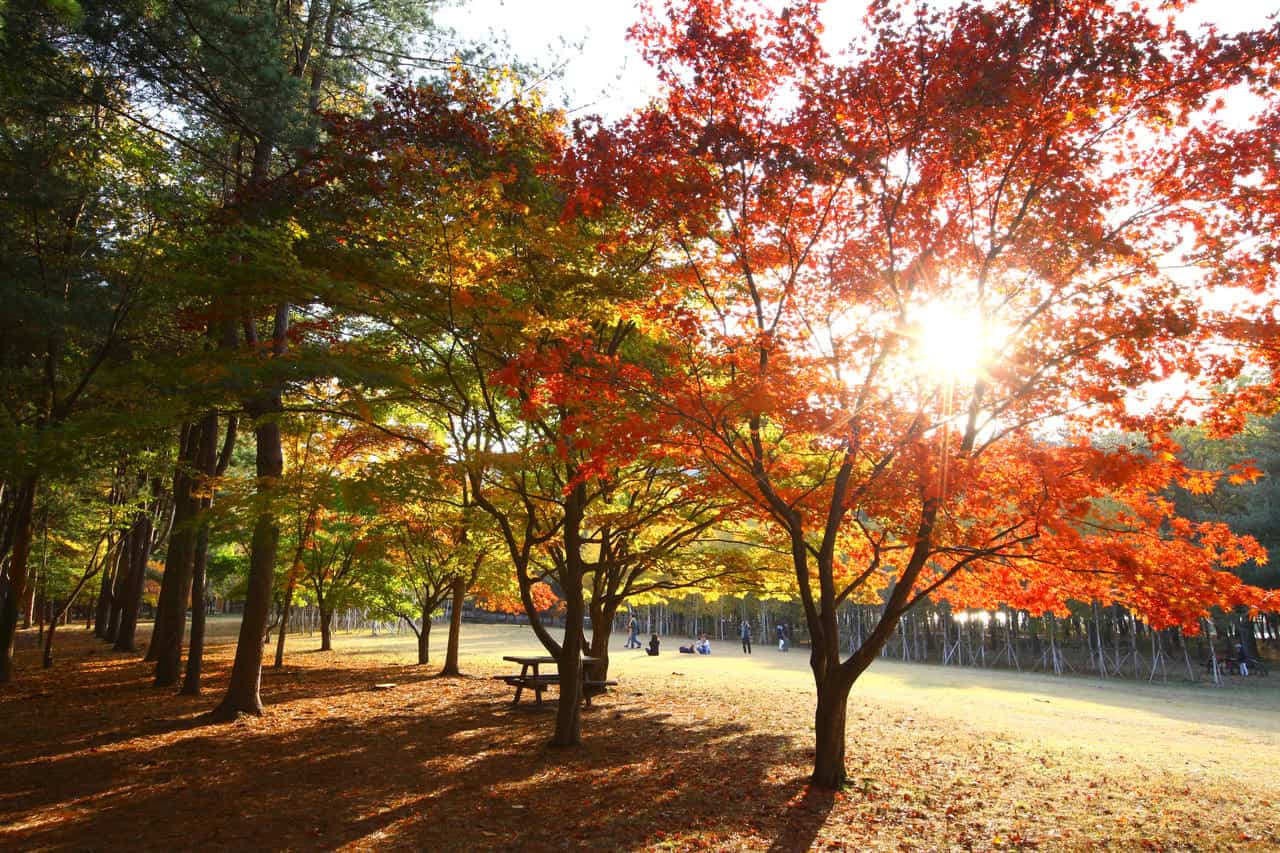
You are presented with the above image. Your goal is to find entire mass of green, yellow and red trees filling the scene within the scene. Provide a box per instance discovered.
[0,0,1280,786]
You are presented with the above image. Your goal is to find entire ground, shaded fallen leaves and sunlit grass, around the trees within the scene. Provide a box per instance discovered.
[0,622,1280,850]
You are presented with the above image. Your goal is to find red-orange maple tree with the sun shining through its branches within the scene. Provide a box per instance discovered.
[572,0,1275,786]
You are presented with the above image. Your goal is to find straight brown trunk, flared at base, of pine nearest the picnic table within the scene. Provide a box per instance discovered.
[212,404,284,720]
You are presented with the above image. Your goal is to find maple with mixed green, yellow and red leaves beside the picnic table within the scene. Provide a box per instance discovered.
[300,73,680,744]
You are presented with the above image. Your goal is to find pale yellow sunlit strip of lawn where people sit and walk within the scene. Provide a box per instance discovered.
[302,614,1280,784]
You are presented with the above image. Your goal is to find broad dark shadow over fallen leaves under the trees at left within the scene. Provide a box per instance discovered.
[0,640,831,850]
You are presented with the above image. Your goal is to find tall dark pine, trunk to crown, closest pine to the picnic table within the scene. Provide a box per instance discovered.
[74,0,445,719]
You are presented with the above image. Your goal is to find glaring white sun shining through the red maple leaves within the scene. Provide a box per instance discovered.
[909,302,998,383]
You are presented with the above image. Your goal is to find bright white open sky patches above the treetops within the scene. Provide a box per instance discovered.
[436,0,1280,118]
